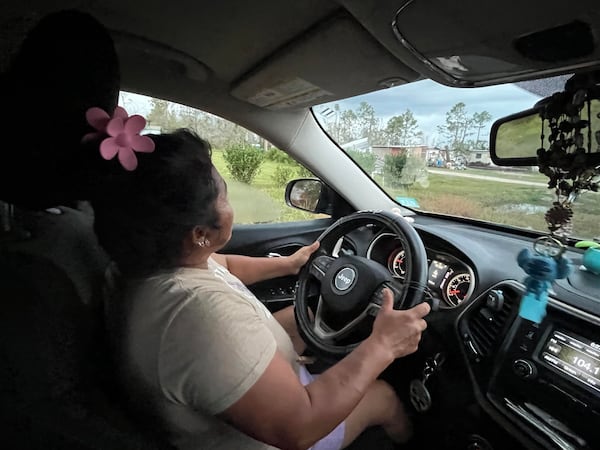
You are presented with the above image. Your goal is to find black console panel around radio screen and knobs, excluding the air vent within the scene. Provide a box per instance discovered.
[487,307,600,449]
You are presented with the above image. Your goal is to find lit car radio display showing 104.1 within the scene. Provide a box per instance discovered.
[541,330,600,392]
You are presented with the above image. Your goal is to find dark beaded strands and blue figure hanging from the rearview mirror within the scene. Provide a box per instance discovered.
[517,76,600,324]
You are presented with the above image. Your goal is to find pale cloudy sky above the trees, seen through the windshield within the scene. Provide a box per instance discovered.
[315,80,555,145]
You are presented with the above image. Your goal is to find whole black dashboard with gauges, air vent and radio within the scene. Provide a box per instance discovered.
[336,217,600,450]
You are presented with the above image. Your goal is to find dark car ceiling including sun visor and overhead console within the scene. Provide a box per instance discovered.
[0,0,600,116]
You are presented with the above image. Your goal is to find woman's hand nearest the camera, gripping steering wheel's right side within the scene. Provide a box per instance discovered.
[368,289,431,359]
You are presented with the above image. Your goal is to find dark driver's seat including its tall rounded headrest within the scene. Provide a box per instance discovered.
[0,11,170,450]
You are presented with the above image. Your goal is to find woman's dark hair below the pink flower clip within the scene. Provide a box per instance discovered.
[88,129,219,277]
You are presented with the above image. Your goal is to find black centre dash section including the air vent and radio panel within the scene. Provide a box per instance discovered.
[458,283,600,450]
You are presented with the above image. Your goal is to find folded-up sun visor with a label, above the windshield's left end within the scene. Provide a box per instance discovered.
[231,16,418,110]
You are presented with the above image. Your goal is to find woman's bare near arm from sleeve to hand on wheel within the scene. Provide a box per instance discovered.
[220,291,429,449]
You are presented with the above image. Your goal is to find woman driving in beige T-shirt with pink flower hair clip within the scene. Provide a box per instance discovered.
[82,124,429,450]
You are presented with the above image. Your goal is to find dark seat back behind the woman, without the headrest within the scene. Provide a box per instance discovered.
[0,207,171,449]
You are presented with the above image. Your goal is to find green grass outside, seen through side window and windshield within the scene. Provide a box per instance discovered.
[213,151,600,238]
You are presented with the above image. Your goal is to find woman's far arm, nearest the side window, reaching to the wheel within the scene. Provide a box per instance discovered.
[212,241,319,285]
